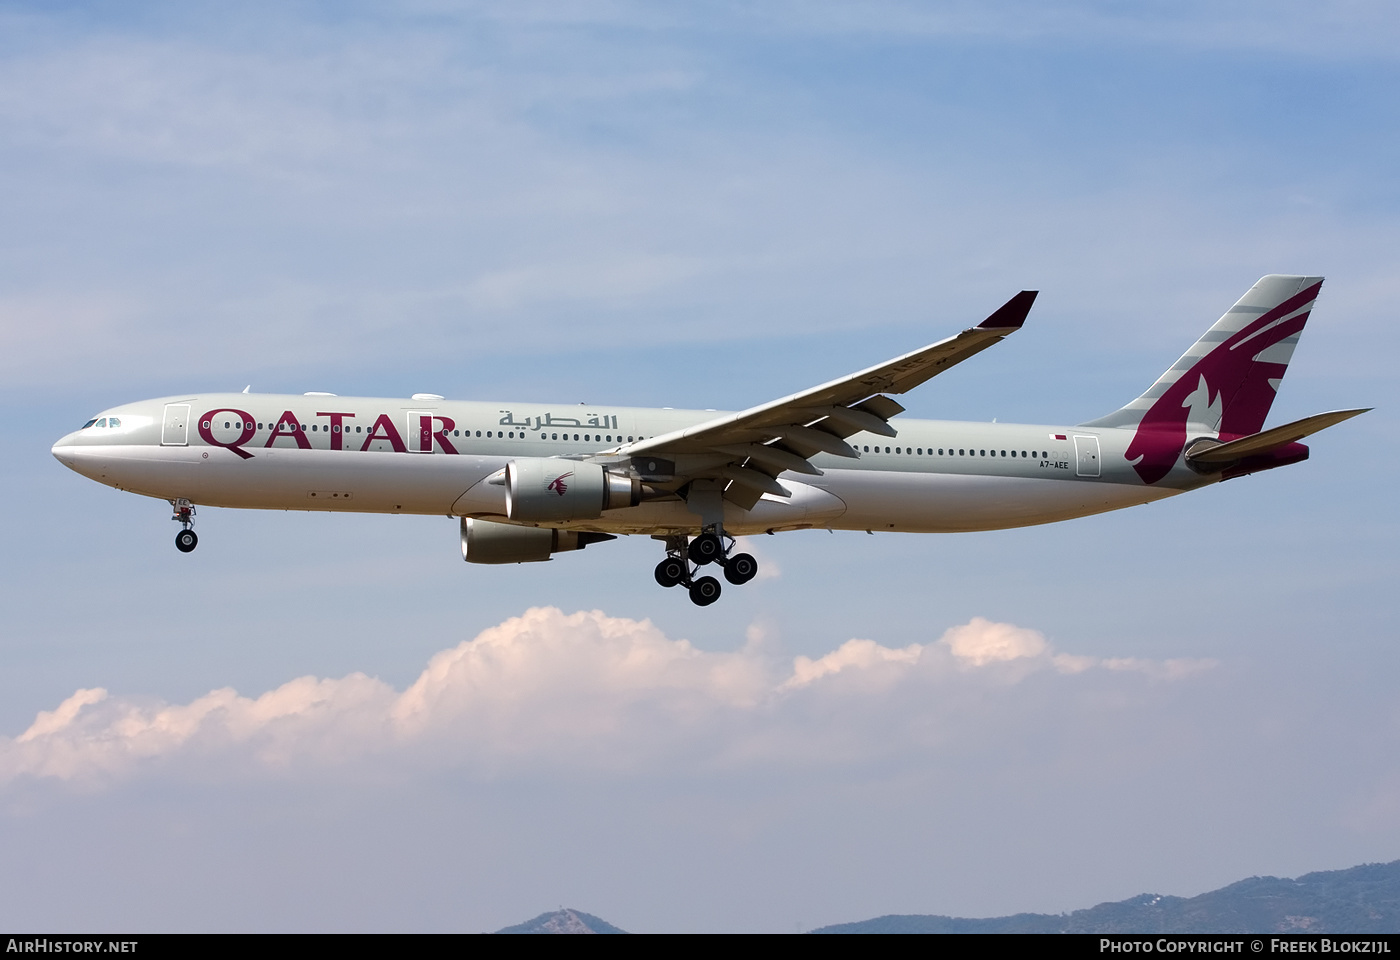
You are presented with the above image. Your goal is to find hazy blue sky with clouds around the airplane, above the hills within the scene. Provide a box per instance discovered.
[0,0,1400,932]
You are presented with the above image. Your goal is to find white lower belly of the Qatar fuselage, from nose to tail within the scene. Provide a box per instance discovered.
[87,446,1180,535]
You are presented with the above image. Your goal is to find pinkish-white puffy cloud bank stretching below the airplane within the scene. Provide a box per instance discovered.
[0,607,1211,784]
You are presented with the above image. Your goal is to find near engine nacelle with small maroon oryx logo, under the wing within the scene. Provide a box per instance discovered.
[505,458,643,523]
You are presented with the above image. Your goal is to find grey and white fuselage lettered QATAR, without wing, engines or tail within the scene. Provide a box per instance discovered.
[53,393,1214,535]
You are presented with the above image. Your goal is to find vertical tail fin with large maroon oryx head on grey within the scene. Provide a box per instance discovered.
[1084,274,1322,483]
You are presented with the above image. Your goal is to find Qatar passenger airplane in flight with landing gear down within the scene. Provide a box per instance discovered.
[53,274,1371,606]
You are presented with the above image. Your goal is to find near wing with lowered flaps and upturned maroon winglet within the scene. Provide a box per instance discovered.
[609,290,1037,508]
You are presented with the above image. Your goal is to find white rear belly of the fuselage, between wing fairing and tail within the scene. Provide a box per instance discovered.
[818,470,1179,533]
